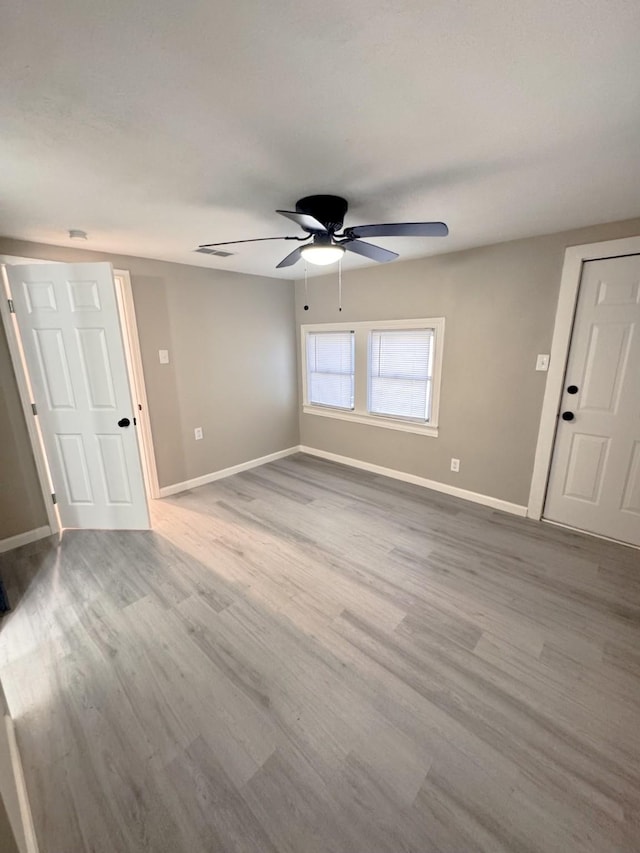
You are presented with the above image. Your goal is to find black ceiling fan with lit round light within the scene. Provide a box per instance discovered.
[198,195,449,269]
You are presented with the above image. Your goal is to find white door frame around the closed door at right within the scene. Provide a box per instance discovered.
[527,236,640,521]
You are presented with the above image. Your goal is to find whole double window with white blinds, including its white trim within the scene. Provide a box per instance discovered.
[301,317,444,437]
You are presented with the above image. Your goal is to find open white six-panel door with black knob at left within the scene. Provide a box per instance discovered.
[7,263,149,530]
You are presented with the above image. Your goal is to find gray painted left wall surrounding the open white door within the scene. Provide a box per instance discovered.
[0,238,298,539]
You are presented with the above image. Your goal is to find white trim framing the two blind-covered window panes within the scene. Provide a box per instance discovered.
[300,317,444,438]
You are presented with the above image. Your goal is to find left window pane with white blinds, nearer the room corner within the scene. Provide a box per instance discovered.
[307,331,355,409]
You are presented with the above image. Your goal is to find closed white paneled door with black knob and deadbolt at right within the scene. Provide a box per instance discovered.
[544,255,640,545]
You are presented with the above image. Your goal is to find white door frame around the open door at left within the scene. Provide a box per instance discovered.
[0,255,160,535]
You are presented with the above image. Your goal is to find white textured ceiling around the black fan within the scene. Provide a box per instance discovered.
[0,0,640,277]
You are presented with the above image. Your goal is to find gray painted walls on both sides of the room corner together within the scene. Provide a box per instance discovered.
[5,213,640,539]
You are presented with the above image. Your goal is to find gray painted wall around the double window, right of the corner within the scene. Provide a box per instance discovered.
[296,219,640,505]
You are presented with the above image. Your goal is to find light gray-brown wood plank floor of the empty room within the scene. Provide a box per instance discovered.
[0,456,640,853]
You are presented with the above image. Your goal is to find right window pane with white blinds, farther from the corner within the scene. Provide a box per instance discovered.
[368,329,433,423]
